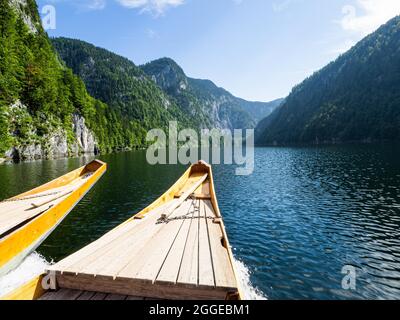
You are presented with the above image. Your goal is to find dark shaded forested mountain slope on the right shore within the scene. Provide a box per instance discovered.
[256,17,400,144]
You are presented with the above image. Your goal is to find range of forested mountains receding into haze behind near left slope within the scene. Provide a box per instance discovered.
[52,42,279,129]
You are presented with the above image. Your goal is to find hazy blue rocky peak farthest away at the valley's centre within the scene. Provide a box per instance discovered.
[141,58,282,129]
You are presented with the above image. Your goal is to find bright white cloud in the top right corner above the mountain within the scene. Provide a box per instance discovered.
[339,0,400,36]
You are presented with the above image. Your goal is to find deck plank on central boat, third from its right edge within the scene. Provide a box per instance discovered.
[177,200,199,285]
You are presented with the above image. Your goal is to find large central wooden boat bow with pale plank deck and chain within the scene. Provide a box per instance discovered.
[4,162,242,300]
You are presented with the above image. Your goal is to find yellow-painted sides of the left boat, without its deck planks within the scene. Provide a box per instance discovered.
[0,160,107,275]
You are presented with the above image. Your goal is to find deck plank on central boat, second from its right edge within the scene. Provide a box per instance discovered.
[199,200,217,287]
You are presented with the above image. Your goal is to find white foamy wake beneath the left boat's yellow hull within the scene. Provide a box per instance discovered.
[0,252,50,297]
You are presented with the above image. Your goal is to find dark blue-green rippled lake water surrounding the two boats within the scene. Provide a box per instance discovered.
[0,144,400,299]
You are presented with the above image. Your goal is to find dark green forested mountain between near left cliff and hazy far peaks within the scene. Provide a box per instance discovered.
[52,38,198,131]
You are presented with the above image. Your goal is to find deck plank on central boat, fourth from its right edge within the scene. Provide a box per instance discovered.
[156,202,195,284]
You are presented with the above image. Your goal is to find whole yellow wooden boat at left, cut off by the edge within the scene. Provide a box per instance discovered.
[0,160,106,276]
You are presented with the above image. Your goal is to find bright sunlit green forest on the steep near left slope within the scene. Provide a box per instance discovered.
[0,0,158,157]
